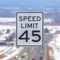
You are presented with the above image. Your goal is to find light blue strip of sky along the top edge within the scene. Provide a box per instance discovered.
[0,0,60,9]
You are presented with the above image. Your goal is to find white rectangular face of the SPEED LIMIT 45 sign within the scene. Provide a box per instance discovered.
[16,12,43,46]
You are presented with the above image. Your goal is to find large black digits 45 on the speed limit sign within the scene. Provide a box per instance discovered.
[19,30,41,42]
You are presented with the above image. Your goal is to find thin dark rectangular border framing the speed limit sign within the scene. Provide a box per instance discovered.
[16,12,44,48]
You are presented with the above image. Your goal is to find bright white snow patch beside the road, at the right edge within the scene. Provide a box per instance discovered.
[49,34,60,60]
